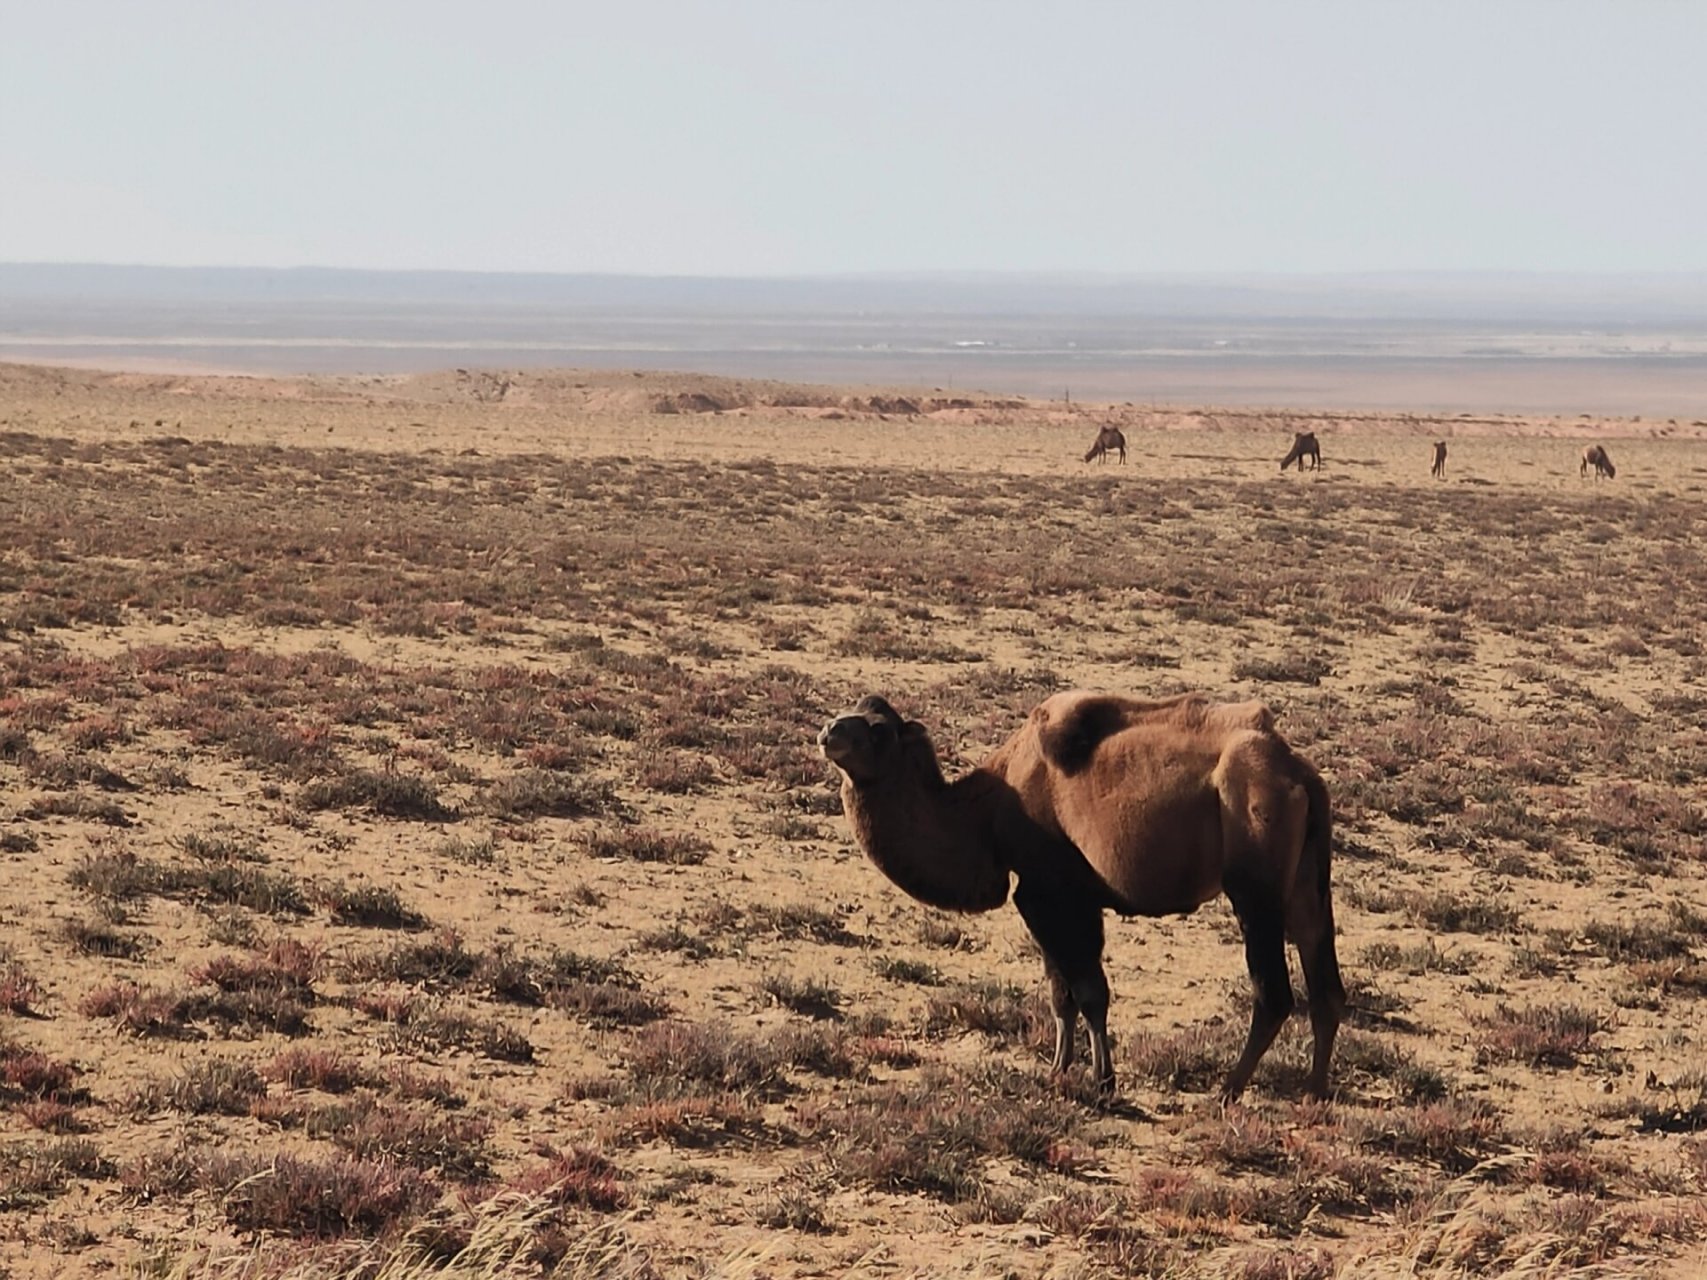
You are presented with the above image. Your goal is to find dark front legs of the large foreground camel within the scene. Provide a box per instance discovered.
[1014,879,1115,1092]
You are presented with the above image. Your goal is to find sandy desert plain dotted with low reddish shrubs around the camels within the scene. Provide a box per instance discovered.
[0,365,1707,1280]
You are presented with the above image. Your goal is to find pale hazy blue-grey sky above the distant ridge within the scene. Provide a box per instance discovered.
[0,0,1707,275]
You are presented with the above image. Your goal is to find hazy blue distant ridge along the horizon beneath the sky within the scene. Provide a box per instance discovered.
[10,263,1707,331]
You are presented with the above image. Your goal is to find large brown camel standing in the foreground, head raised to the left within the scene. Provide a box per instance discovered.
[818,691,1345,1099]
